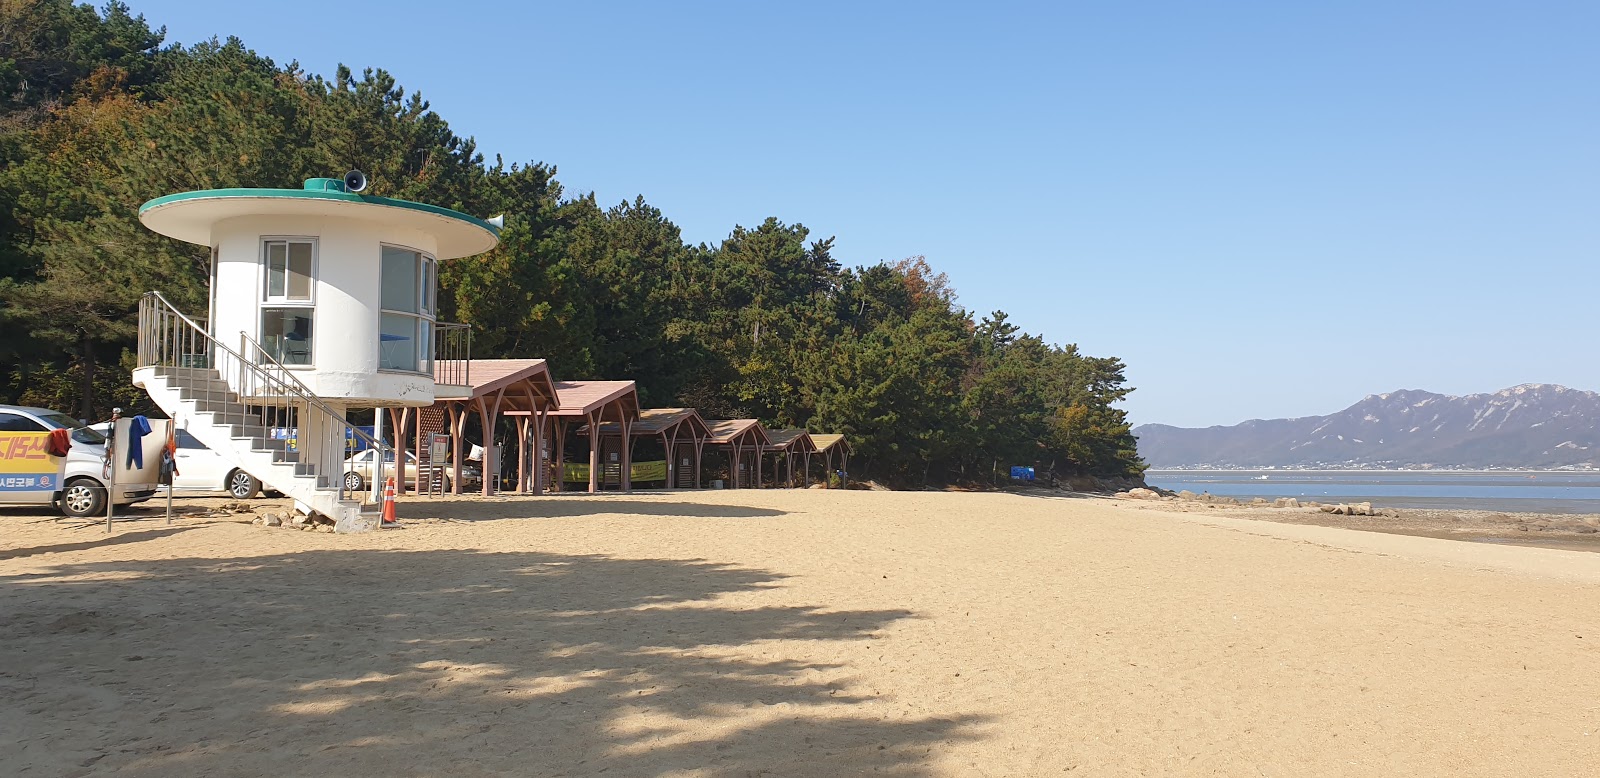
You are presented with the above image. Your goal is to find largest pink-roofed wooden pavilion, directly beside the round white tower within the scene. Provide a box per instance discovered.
[389,359,557,496]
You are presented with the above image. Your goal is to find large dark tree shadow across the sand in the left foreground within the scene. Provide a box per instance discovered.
[0,551,982,776]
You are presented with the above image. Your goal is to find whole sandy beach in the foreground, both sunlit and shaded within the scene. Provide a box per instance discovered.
[0,490,1600,776]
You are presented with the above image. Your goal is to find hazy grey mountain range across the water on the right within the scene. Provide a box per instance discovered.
[1133,384,1600,469]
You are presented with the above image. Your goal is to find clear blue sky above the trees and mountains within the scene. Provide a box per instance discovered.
[128,0,1600,426]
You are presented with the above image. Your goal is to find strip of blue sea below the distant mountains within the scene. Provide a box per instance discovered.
[1144,471,1600,514]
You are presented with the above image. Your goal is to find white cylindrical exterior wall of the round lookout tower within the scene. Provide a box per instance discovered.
[210,216,437,407]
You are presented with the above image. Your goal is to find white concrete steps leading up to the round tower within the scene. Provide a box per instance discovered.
[133,367,379,531]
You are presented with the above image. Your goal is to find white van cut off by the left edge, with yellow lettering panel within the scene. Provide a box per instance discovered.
[0,405,155,517]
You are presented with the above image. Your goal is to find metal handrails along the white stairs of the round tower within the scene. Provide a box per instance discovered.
[138,291,389,509]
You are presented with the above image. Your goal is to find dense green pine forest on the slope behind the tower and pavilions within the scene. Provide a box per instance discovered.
[0,0,1144,487]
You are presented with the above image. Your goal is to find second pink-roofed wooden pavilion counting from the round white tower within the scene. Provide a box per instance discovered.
[550,381,638,493]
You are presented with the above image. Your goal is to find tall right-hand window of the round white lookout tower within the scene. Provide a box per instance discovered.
[378,247,435,373]
